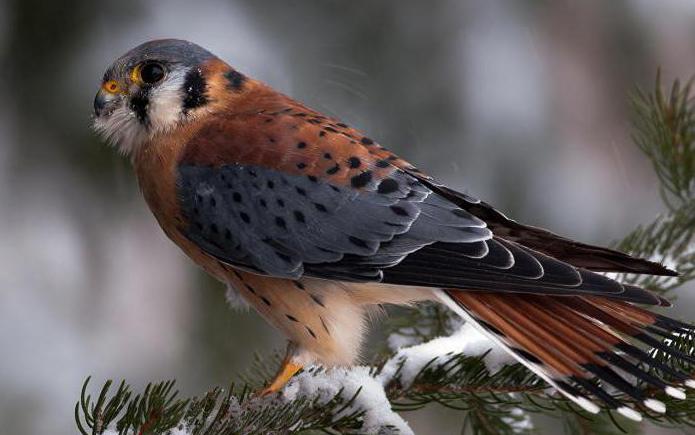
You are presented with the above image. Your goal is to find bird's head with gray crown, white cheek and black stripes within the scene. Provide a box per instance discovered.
[94,39,231,154]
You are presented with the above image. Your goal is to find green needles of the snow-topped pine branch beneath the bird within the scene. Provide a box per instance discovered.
[75,336,695,435]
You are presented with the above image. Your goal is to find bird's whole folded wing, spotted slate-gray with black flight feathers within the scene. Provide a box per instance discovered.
[178,165,660,304]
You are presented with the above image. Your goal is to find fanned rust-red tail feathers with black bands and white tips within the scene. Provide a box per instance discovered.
[445,290,695,420]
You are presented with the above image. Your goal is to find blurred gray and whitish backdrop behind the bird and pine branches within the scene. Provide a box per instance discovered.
[0,0,695,435]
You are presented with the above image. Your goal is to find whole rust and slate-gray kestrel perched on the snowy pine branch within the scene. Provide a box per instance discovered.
[93,39,695,420]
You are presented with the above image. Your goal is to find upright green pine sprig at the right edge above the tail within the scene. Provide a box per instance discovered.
[617,73,695,293]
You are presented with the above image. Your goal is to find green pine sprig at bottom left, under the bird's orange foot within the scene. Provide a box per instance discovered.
[75,378,364,435]
